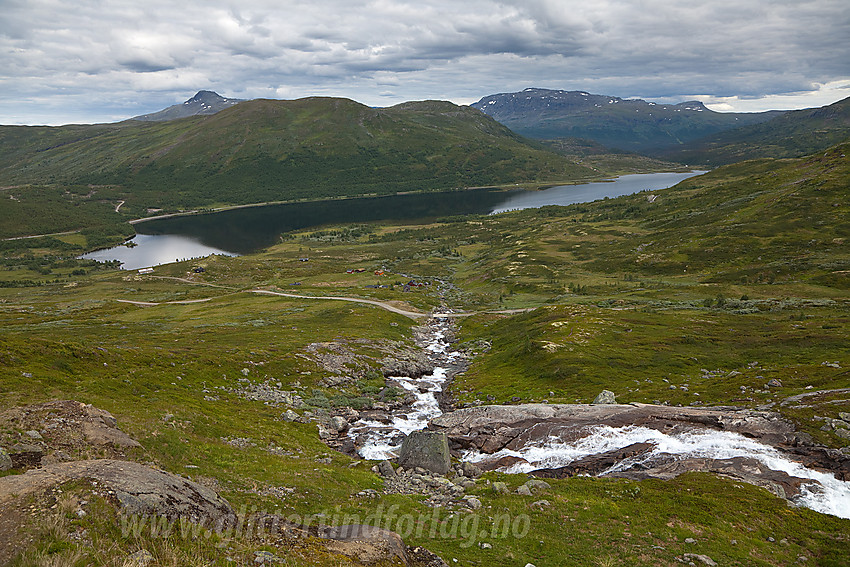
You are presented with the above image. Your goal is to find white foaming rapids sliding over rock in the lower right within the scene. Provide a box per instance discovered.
[463,425,850,518]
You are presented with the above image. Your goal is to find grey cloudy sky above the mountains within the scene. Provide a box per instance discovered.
[0,0,850,124]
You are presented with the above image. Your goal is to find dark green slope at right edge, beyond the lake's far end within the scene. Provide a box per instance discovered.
[657,98,850,165]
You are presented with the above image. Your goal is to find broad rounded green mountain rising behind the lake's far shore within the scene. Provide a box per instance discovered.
[0,98,598,210]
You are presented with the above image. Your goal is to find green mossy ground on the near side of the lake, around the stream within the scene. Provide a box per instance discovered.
[0,143,850,567]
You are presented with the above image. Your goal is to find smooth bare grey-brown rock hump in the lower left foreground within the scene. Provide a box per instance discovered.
[0,459,236,526]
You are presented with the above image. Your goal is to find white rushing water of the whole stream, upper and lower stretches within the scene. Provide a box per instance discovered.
[348,318,850,518]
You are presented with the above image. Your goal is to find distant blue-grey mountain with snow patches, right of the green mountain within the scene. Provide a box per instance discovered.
[472,88,782,154]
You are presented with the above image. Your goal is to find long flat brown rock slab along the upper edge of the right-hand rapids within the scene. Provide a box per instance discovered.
[429,404,850,486]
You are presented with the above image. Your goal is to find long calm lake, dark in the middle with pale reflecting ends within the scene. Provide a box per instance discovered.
[83,171,703,270]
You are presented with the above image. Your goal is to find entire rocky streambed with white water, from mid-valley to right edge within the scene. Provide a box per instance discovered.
[332,317,850,518]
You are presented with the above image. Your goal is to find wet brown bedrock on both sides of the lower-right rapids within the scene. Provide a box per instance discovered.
[430,404,850,498]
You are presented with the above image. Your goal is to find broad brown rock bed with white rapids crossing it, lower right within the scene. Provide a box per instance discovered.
[429,404,850,518]
